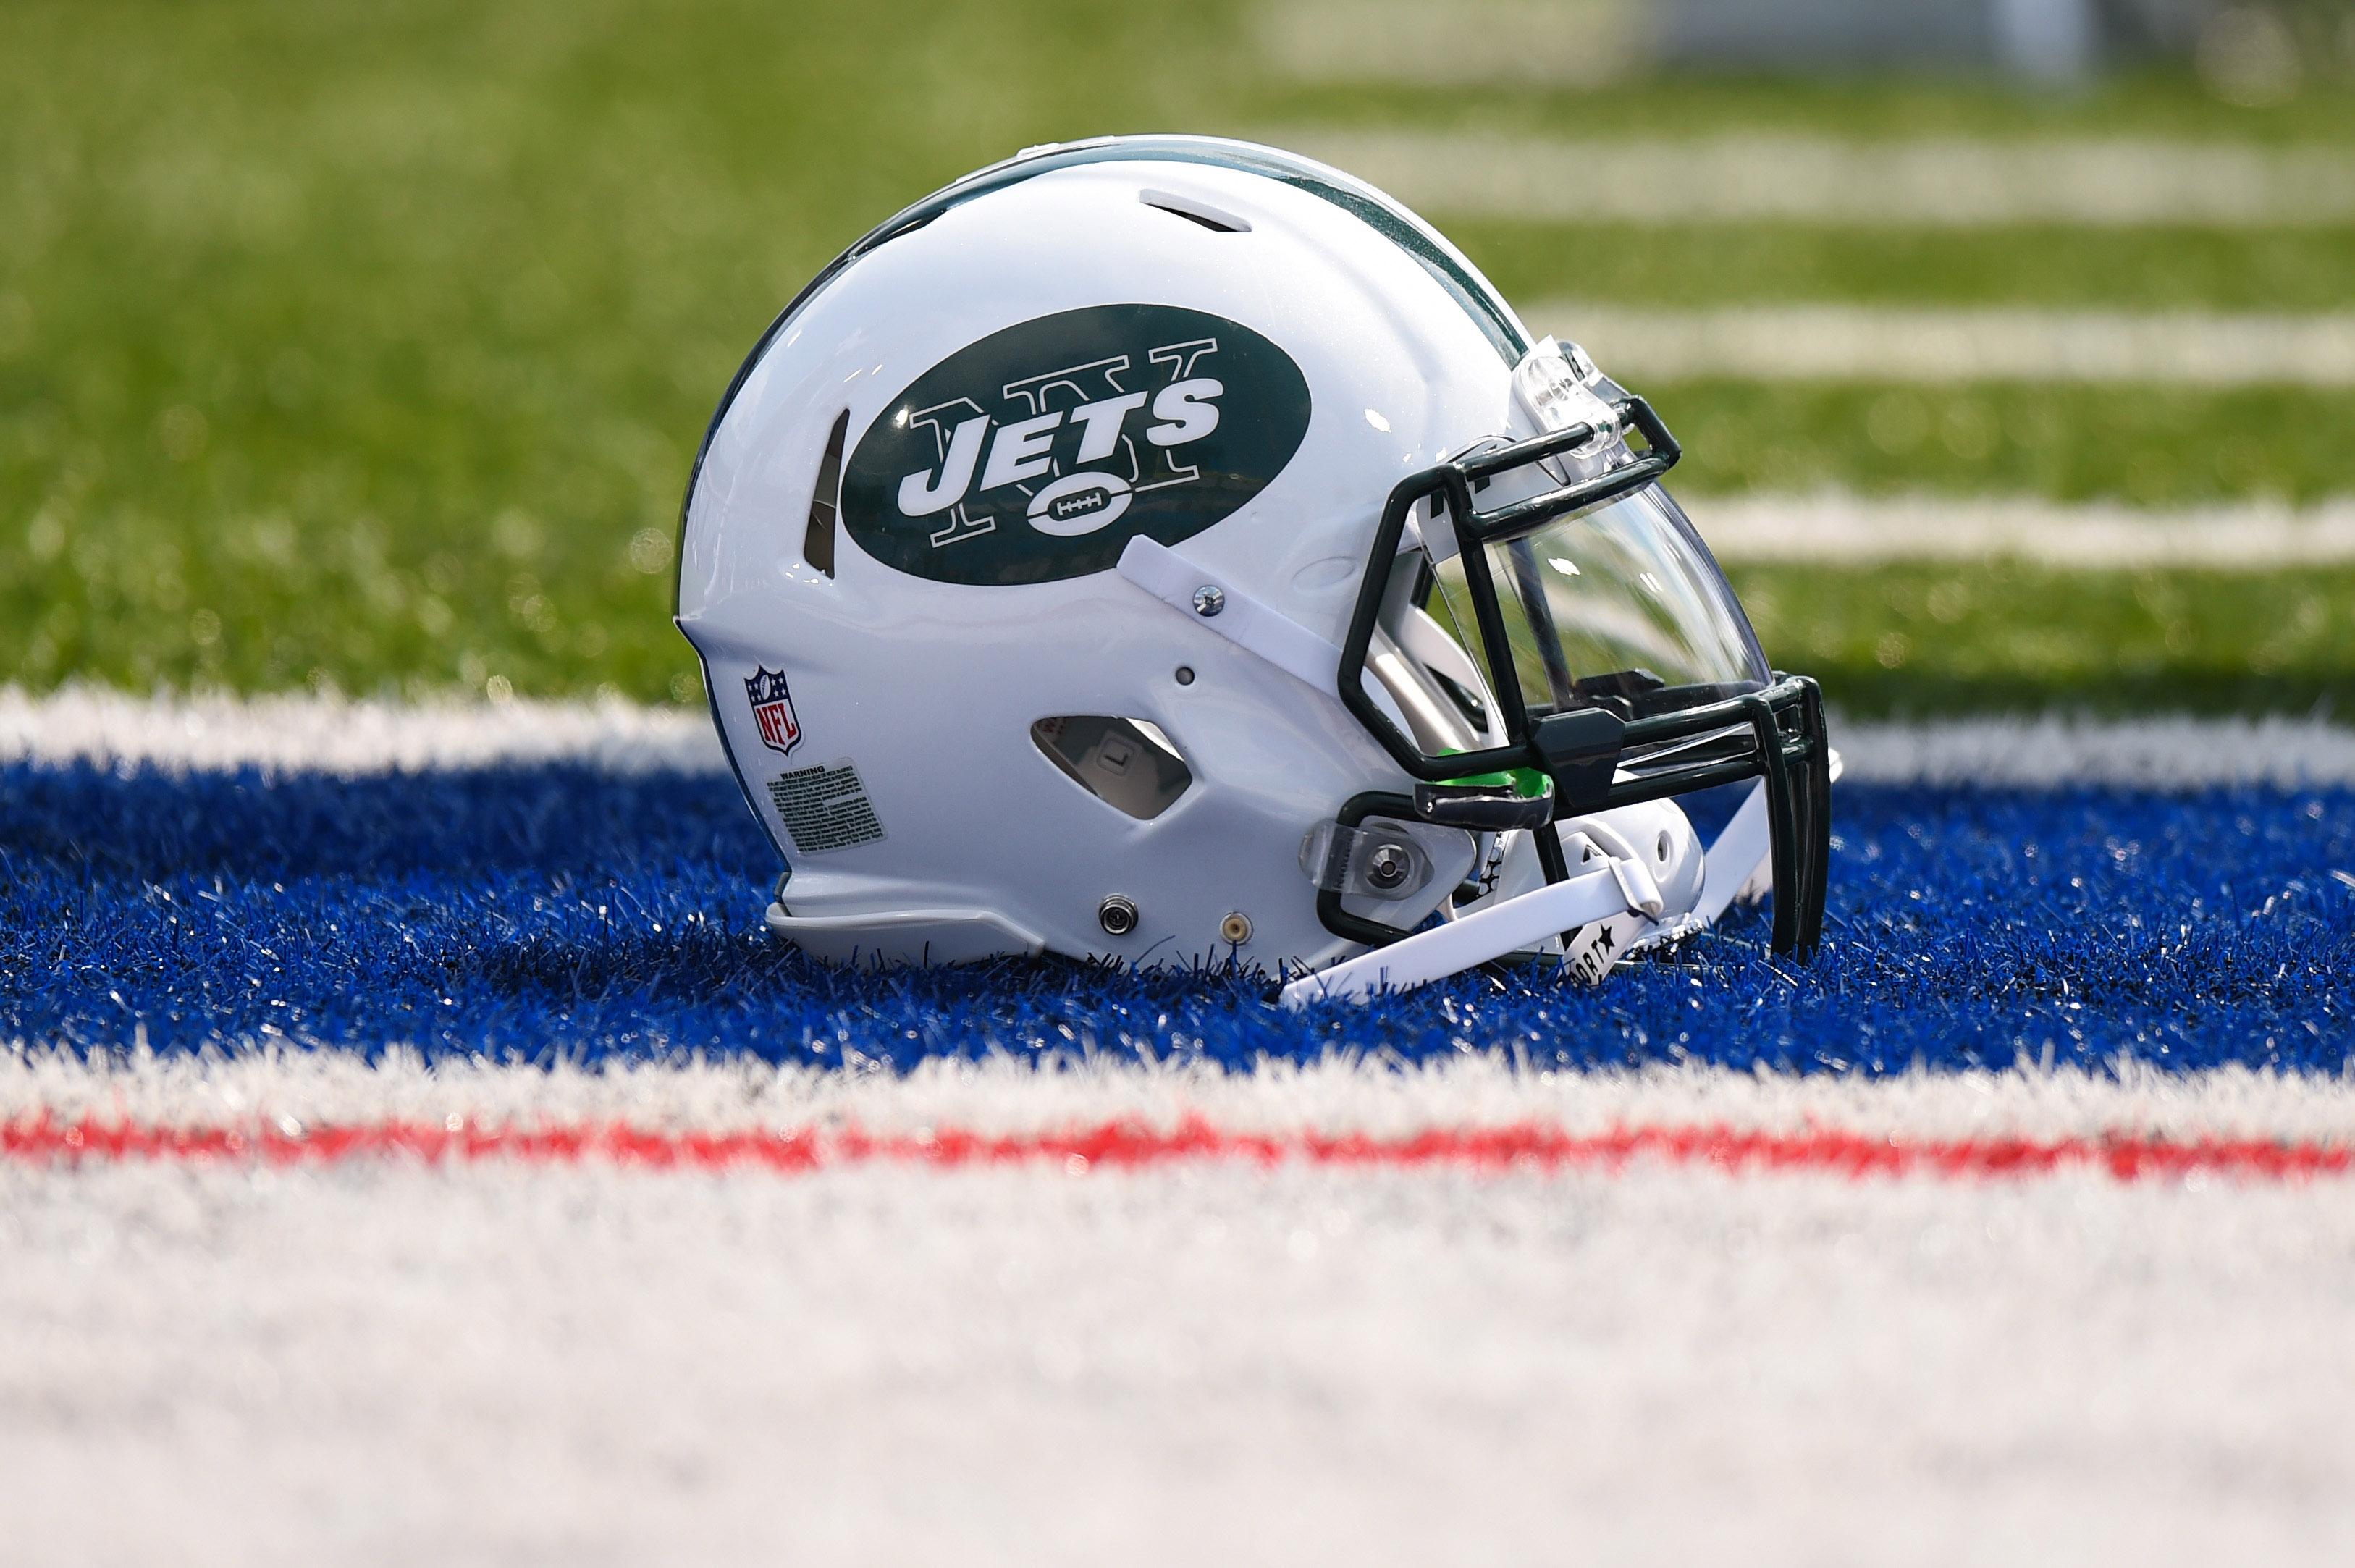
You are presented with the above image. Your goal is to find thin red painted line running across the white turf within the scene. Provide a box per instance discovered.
[0,1113,2355,1182]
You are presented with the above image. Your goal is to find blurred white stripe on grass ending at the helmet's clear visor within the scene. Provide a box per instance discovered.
[1684,492,2355,572]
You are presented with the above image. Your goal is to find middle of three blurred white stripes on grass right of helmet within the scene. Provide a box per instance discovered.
[1524,299,2355,389]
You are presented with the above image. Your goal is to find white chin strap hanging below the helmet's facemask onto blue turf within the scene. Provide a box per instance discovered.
[1281,760,1837,1008]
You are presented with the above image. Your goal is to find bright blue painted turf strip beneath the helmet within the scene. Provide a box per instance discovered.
[0,765,2355,1071]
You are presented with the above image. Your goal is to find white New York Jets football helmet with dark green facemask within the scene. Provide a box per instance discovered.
[678,137,1832,1003]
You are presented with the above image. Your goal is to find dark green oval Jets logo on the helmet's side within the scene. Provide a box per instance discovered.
[841,304,1310,586]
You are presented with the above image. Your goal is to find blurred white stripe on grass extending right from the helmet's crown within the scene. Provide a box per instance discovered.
[1265,127,2355,228]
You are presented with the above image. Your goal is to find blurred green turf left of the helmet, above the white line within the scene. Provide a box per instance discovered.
[0,0,1252,699]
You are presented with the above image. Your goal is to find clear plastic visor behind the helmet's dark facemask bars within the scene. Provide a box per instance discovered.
[1430,485,1771,718]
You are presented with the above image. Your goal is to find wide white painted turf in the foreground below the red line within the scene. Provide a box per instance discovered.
[0,1134,2355,1568]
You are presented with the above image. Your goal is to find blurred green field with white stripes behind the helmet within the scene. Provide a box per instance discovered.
[0,0,2355,713]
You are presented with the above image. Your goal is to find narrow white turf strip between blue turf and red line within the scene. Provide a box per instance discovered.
[14,1043,2355,1142]
